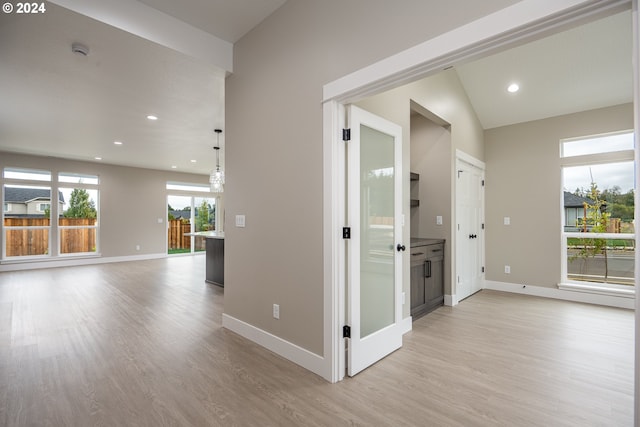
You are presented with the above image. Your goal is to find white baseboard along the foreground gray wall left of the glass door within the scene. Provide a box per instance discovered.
[222,314,331,382]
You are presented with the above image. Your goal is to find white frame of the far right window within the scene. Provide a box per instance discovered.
[558,130,638,296]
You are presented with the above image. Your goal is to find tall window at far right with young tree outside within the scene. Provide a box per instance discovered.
[560,132,635,290]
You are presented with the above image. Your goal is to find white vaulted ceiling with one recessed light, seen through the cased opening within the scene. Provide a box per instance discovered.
[456,11,633,129]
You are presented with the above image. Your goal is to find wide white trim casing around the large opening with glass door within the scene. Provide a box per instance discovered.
[322,0,640,384]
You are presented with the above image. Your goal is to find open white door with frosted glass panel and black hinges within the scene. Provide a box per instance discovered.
[346,106,405,376]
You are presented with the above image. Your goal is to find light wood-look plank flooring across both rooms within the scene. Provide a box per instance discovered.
[0,256,634,427]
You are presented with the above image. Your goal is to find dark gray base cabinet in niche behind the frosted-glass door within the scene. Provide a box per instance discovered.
[411,239,444,320]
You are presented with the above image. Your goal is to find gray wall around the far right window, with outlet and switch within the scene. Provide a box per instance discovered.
[485,104,633,288]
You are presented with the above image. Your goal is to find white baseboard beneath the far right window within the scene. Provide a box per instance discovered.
[484,280,635,310]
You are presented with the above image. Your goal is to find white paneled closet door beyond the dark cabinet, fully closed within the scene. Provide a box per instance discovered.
[456,160,484,301]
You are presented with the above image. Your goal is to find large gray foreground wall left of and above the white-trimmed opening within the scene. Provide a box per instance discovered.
[225,0,517,355]
